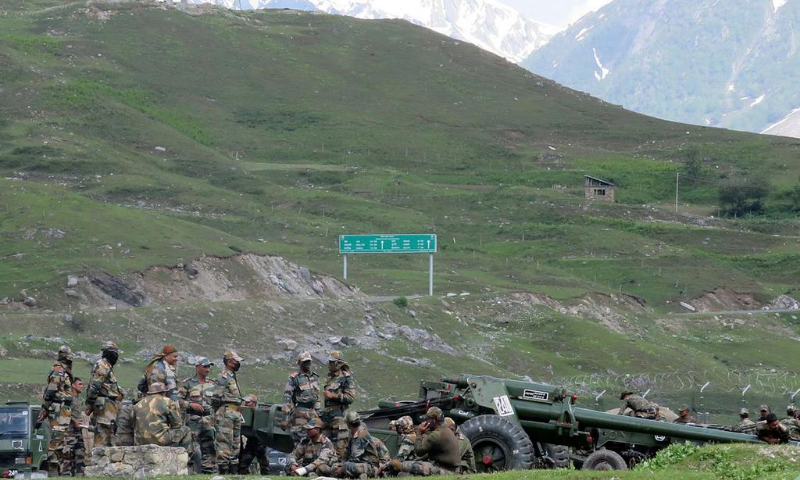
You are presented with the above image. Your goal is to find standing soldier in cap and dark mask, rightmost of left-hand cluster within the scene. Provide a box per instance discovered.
[211,350,244,474]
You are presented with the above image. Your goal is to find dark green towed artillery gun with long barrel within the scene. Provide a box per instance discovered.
[245,375,761,472]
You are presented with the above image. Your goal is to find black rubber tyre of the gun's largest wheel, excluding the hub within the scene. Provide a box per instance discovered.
[459,415,536,470]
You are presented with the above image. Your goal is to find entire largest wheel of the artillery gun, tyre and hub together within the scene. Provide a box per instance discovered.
[459,415,535,473]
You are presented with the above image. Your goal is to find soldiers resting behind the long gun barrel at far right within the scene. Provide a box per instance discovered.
[617,391,800,444]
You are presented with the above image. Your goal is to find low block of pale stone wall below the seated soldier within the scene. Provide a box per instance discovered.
[86,445,189,478]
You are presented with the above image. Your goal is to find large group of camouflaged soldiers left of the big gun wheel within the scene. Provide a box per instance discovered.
[40,342,475,478]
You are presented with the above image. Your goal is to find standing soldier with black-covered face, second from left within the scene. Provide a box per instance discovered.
[86,342,122,447]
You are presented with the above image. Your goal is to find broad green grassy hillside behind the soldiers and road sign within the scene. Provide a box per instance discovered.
[0,0,800,411]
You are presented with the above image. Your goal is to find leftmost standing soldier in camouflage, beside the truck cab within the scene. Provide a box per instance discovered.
[39,345,73,476]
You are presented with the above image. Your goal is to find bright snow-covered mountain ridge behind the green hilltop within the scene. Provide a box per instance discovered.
[181,0,557,62]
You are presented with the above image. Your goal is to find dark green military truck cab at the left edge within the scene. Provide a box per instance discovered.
[0,401,50,478]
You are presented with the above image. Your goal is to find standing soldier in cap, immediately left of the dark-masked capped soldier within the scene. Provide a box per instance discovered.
[178,357,217,475]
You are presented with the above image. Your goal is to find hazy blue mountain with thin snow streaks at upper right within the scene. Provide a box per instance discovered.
[522,0,800,137]
